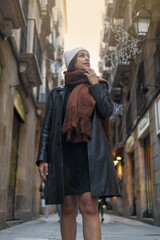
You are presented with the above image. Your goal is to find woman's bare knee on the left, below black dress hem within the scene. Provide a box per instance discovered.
[61,196,77,215]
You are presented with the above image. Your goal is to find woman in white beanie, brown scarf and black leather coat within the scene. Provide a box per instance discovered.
[37,47,119,240]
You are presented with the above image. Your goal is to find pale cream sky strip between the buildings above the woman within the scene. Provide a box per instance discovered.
[64,0,104,74]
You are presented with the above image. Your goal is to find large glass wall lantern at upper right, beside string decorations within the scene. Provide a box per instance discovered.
[133,7,151,37]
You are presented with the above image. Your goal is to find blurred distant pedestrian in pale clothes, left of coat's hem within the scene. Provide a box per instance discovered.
[39,181,50,223]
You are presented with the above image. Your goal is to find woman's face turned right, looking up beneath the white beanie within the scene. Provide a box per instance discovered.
[74,50,90,70]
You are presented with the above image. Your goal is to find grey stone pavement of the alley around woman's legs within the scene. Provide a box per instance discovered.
[0,214,160,240]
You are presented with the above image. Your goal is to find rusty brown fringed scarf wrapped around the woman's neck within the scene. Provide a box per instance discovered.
[62,70,109,143]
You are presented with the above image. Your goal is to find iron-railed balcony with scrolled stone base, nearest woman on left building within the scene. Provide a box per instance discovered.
[19,19,42,90]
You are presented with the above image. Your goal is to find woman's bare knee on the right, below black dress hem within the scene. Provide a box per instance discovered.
[80,194,98,215]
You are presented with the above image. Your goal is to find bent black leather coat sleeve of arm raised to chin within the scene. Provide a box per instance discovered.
[89,83,113,119]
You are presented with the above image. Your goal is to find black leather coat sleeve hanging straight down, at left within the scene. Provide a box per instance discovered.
[36,91,53,166]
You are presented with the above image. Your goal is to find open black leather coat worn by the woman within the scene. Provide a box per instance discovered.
[36,83,119,204]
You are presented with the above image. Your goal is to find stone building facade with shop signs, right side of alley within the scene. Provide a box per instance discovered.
[100,0,160,226]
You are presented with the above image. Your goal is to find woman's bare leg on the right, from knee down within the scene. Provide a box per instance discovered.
[80,192,101,240]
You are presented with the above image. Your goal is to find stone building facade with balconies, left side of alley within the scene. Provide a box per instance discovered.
[0,0,66,229]
